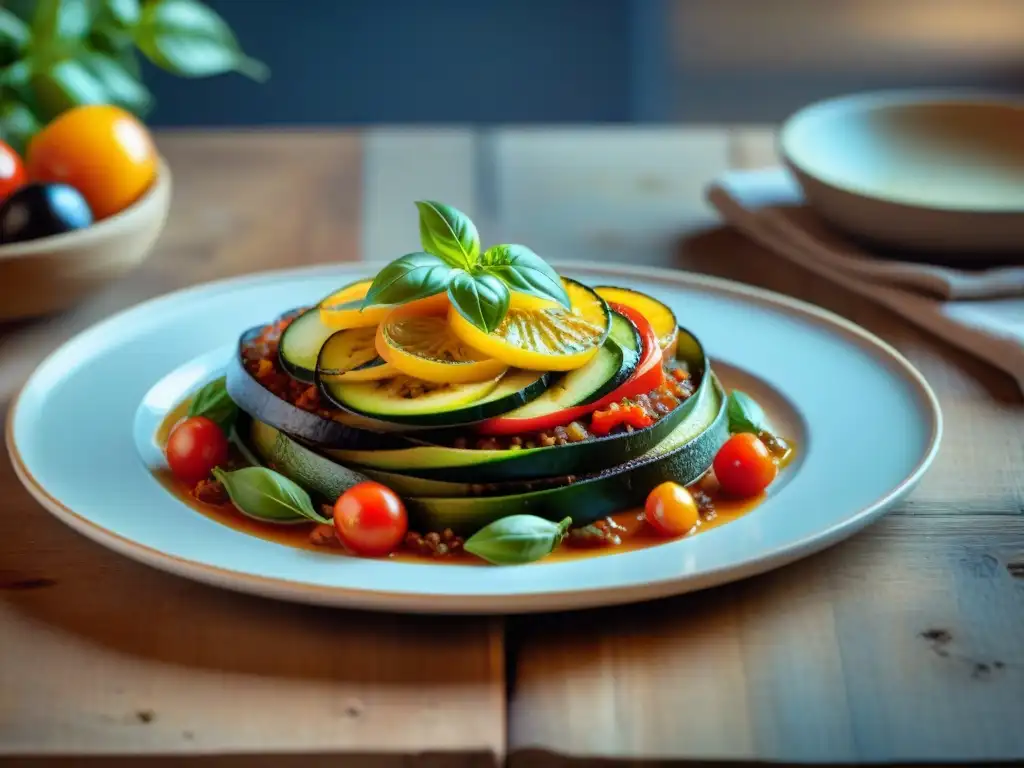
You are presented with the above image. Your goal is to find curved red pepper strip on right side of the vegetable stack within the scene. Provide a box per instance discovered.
[476,303,665,435]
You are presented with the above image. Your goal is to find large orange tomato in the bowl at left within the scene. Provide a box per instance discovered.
[27,104,158,220]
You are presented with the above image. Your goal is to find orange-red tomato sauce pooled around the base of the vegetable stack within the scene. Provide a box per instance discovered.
[155,401,796,565]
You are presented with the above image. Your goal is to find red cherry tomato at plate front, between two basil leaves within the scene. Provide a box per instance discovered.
[334,480,409,557]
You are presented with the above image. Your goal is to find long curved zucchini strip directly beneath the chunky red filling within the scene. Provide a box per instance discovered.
[325,329,712,483]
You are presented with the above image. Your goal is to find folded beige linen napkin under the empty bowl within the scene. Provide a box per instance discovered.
[708,168,1024,392]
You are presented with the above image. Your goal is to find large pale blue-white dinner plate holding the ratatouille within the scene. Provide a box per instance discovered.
[7,264,941,613]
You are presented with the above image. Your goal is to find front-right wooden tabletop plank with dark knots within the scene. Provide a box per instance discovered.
[509,516,1024,764]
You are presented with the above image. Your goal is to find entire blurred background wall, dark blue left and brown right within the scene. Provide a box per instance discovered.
[146,0,1024,126]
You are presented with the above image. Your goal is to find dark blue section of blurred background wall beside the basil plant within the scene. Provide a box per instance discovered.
[146,0,634,125]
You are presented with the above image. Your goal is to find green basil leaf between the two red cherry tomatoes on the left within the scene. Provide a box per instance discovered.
[213,467,331,523]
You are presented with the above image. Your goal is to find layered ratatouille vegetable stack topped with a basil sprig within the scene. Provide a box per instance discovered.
[165,202,774,562]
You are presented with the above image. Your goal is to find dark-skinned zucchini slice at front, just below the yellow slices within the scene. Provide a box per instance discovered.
[319,370,551,428]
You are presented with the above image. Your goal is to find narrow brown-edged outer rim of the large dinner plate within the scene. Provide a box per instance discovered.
[4,260,943,615]
